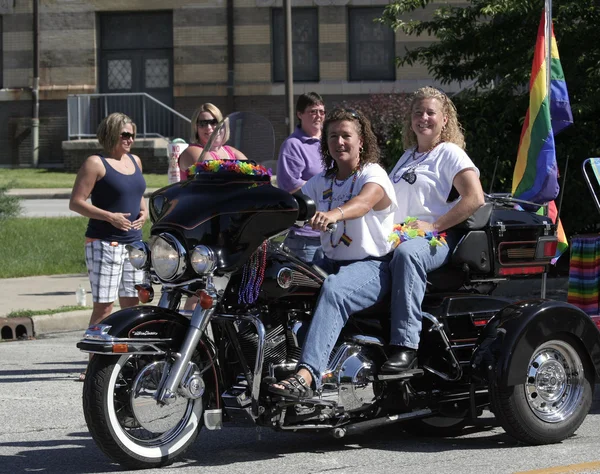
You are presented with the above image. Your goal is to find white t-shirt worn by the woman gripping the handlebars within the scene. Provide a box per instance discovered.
[302,163,397,260]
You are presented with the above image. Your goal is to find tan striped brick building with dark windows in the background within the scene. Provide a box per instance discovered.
[0,0,461,167]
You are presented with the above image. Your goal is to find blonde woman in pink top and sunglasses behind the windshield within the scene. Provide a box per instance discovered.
[179,102,248,181]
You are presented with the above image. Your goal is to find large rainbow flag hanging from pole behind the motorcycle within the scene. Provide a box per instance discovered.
[512,14,573,204]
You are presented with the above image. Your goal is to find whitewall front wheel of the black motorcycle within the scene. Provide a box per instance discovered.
[83,355,203,469]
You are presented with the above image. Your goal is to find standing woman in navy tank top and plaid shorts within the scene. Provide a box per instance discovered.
[69,113,148,370]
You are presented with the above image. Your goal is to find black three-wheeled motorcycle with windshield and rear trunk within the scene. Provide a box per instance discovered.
[77,114,600,469]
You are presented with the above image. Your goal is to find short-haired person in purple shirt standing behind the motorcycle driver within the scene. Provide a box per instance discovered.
[277,92,325,263]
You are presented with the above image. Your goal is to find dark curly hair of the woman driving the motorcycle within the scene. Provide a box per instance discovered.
[321,109,379,176]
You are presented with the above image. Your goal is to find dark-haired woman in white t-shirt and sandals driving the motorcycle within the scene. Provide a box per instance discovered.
[269,109,397,399]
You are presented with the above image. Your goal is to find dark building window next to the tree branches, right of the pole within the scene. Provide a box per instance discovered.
[348,8,396,81]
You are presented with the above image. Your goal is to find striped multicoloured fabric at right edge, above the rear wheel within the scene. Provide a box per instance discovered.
[567,235,600,315]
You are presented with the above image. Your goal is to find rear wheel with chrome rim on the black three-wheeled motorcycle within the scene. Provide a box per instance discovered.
[490,335,593,445]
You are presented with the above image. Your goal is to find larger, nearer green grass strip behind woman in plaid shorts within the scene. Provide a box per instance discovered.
[0,217,151,278]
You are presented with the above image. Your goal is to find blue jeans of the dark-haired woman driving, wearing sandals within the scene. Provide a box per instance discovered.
[298,257,391,388]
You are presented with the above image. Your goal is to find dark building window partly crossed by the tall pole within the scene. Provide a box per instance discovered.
[272,8,319,82]
